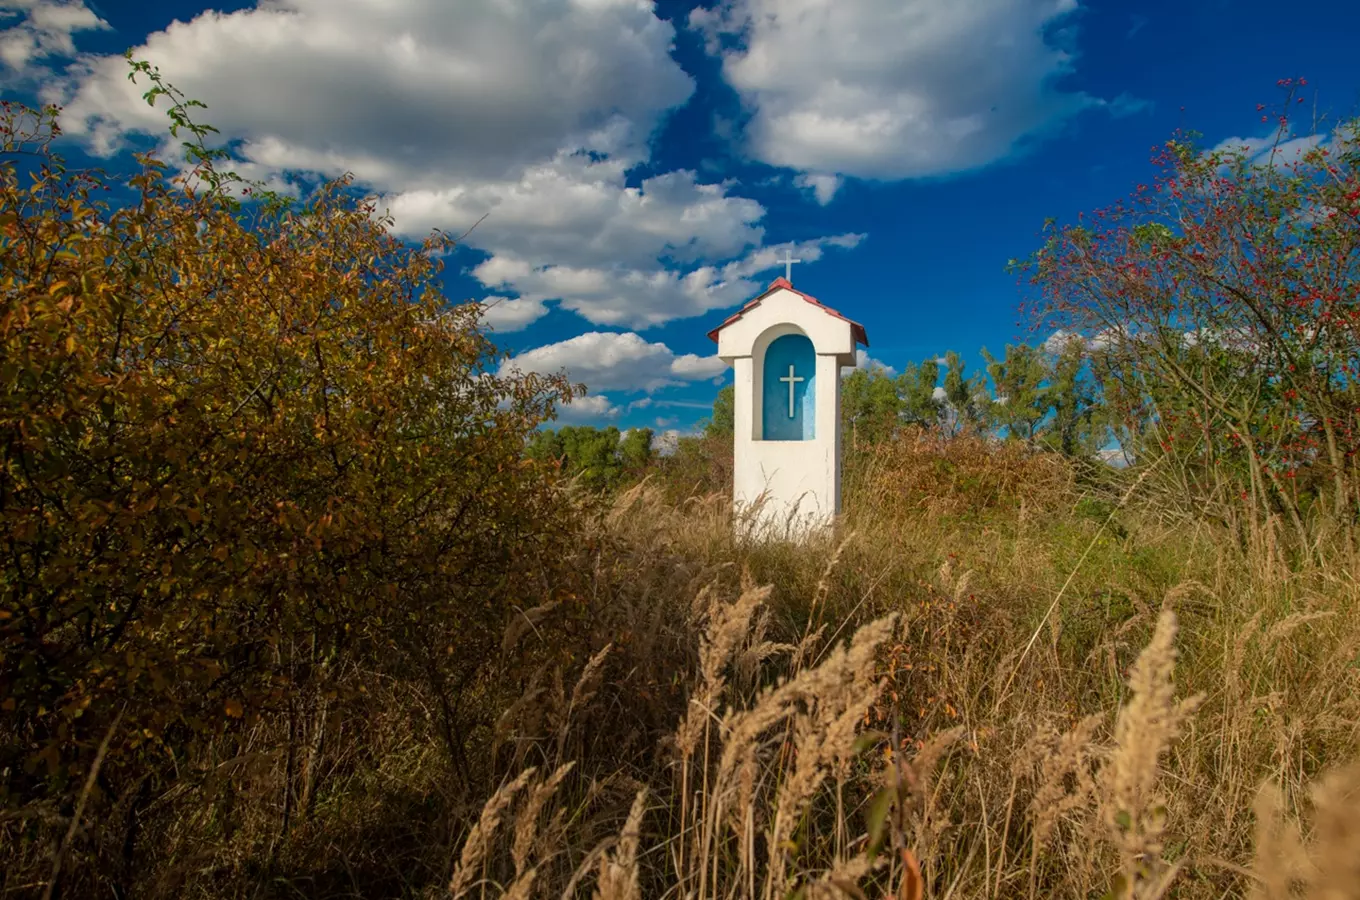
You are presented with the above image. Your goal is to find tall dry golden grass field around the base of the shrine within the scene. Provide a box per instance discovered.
[0,438,1360,900]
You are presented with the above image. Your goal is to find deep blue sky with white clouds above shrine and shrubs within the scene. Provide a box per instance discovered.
[0,0,1360,431]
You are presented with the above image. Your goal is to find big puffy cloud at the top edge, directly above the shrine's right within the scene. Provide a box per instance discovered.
[690,0,1104,178]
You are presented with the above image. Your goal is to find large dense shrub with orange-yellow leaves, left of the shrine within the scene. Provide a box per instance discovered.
[0,93,574,896]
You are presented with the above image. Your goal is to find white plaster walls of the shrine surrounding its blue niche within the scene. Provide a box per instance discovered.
[718,291,854,538]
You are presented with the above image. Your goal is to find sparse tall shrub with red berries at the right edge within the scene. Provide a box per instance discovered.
[1017,79,1360,555]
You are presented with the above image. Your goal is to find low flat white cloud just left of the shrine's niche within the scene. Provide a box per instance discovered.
[500,332,726,392]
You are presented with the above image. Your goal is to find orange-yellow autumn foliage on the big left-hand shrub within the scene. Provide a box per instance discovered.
[0,97,567,815]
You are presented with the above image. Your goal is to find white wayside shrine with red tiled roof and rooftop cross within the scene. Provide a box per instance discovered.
[709,266,869,538]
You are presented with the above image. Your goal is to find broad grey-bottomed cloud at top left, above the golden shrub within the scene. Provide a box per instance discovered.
[53,0,694,186]
